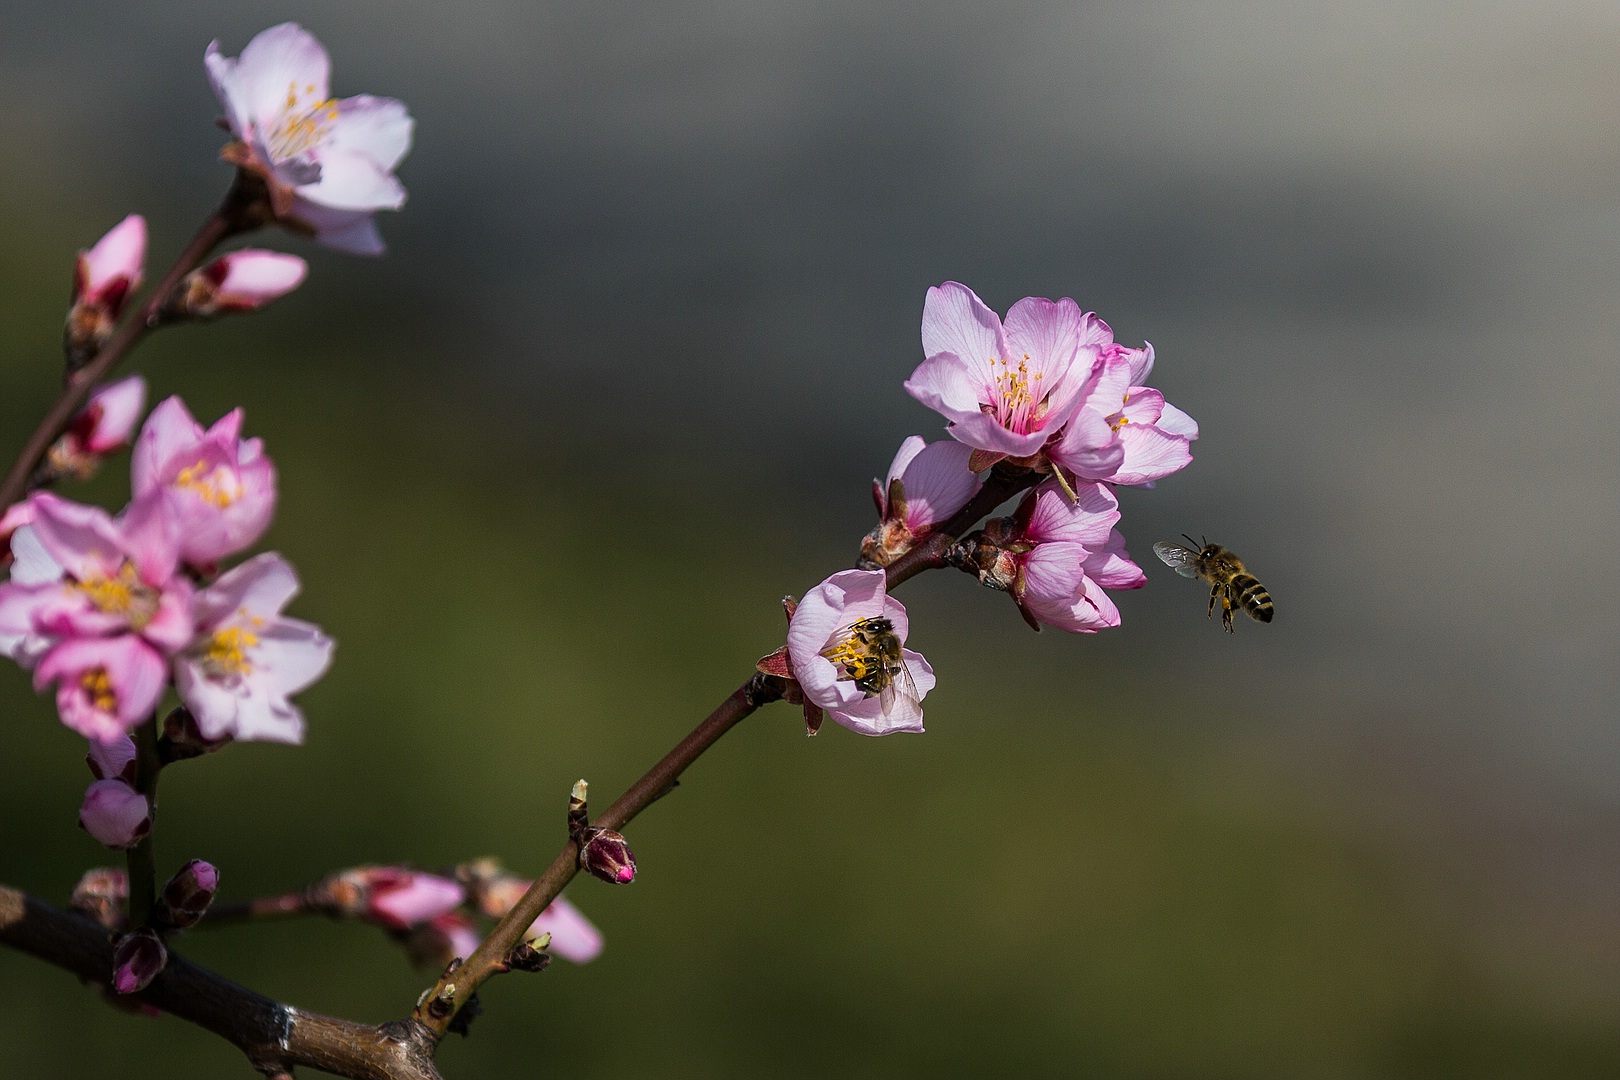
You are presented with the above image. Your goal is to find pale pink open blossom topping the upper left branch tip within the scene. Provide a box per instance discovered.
[204,23,413,254]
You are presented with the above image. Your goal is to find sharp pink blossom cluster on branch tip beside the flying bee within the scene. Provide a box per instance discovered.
[777,282,1199,735]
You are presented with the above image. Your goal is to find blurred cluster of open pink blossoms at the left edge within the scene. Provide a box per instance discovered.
[0,395,332,847]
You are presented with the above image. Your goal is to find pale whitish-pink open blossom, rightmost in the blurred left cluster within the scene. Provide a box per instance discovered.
[175,552,332,743]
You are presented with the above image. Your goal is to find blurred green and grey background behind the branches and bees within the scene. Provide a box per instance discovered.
[0,0,1620,1078]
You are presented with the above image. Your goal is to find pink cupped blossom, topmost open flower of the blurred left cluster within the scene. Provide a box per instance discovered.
[130,397,275,567]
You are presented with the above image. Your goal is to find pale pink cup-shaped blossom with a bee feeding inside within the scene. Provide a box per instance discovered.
[787,570,935,735]
